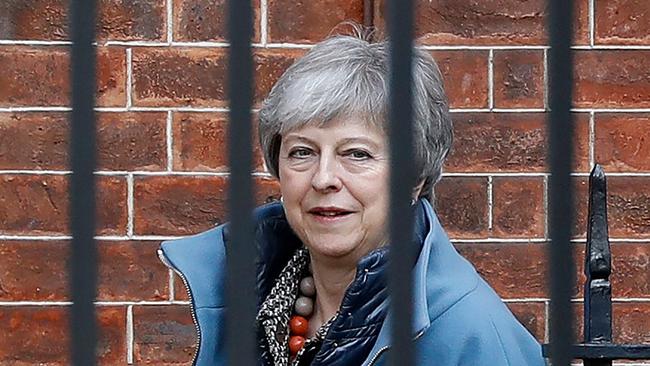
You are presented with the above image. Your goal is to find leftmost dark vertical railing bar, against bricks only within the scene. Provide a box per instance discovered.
[69,0,97,366]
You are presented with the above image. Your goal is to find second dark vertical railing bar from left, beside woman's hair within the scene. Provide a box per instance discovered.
[226,0,257,365]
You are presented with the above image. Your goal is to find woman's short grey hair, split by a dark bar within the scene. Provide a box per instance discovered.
[259,35,453,203]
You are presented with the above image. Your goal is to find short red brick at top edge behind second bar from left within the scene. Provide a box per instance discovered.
[173,0,260,42]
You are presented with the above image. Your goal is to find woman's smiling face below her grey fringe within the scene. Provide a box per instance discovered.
[279,118,389,264]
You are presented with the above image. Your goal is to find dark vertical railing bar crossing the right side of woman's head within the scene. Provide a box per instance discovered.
[387,0,415,366]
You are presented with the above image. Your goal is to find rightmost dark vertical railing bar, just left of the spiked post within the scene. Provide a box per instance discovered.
[547,0,575,366]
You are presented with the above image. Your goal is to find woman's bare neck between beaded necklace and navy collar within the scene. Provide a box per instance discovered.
[310,255,357,330]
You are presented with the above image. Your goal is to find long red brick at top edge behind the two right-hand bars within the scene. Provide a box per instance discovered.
[374,0,589,45]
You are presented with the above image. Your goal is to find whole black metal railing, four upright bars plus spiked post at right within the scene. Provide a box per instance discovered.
[70,0,650,366]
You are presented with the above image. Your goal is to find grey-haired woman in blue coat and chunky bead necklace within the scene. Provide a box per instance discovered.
[160,36,543,366]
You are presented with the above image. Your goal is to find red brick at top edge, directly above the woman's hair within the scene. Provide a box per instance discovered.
[268,0,363,43]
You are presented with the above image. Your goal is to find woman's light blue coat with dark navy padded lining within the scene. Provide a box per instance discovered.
[159,200,545,366]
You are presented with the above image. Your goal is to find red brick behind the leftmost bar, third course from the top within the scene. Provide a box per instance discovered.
[0,112,167,170]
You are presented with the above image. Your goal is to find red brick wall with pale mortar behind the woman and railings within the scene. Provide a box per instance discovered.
[0,0,650,365]
